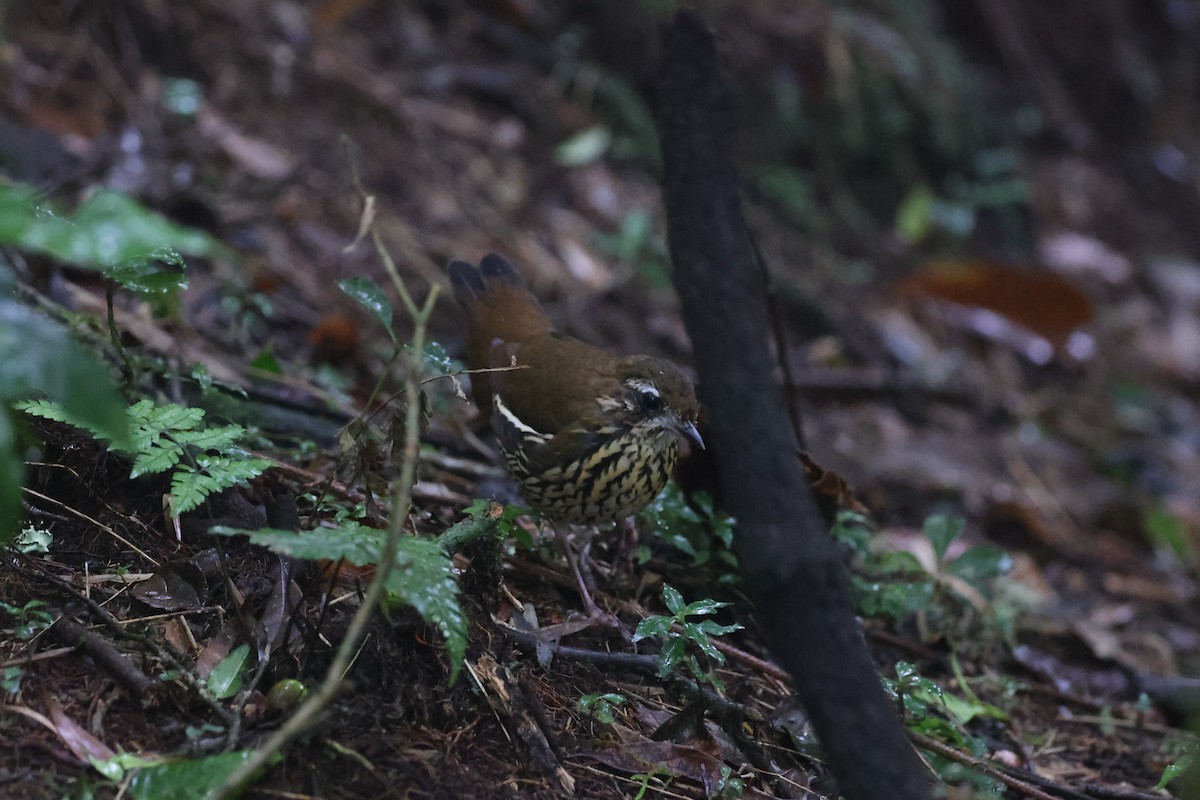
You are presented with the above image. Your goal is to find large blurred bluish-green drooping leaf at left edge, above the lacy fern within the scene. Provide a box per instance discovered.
[0,297,130,445]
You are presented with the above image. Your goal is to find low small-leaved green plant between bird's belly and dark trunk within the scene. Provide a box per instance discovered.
[638,482,739,585]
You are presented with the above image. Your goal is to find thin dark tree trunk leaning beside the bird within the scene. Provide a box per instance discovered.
[659,11,930,800]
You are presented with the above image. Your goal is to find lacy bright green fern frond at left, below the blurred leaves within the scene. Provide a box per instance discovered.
[16,399,271,515]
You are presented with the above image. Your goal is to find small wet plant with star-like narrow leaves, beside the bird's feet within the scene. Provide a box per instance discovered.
[634,584,742,692]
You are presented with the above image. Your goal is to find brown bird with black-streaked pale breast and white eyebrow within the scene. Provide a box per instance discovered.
[448,253,703,610]
